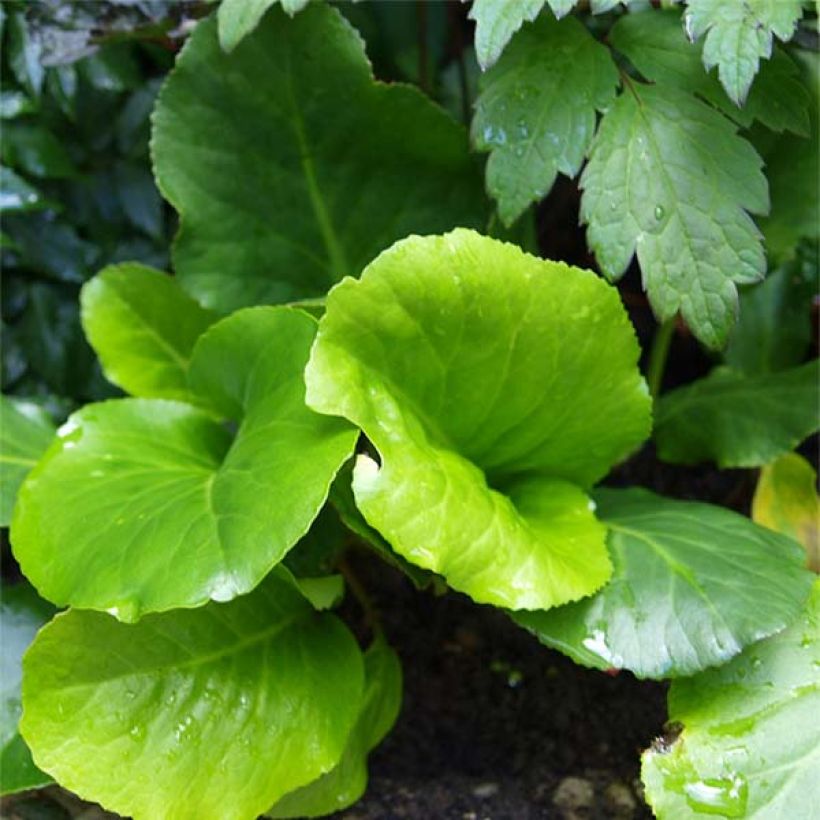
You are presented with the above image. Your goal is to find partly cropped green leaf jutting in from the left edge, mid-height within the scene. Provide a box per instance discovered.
[0,396,55,527]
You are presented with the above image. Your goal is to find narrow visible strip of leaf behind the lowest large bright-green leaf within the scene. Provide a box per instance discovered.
[266,638,402,818]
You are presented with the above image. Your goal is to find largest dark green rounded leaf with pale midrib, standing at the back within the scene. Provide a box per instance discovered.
[153,3,486,311]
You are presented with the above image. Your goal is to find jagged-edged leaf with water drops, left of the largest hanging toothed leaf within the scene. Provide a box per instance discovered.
[471,15,618,225]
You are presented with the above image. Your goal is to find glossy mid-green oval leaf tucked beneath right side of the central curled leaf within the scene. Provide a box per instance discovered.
[514,489,812,678]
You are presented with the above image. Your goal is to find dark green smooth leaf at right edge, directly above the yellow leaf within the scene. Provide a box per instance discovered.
[655,359,820,468]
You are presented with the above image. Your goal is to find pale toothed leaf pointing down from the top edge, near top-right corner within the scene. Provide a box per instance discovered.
[686,0,803,105]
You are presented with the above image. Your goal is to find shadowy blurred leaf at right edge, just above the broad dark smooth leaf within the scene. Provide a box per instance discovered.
[723,260,817,376]
